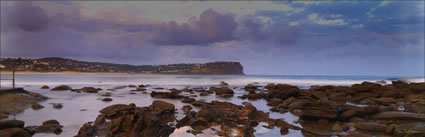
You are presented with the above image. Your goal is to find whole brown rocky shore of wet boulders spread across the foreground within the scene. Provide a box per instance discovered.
[0,81,425,137]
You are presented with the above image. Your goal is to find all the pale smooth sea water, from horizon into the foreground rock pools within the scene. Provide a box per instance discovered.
[0,74,424,137]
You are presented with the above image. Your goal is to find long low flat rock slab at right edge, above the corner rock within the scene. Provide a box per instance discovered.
[373,112,425,121]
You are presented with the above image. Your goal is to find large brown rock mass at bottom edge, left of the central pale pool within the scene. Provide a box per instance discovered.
[75,101,175,137]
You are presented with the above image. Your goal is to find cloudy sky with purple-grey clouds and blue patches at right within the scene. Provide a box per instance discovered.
[0,1,425,76]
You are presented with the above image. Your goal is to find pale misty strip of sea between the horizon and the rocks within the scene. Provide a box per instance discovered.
[1,74,424,87]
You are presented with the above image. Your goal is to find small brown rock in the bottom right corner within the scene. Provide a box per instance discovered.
[394,122,425,137]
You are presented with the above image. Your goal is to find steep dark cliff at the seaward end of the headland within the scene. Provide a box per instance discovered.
[178,62,244,75]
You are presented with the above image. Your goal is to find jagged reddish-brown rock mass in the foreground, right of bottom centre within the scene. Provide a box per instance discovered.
[177,101,299,136]
